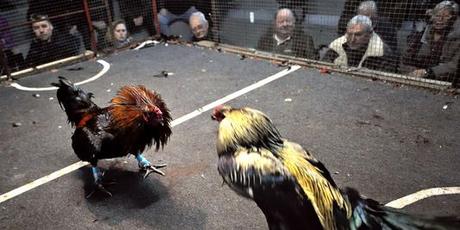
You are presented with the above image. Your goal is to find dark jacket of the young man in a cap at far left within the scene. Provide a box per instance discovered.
[25,31,79,67]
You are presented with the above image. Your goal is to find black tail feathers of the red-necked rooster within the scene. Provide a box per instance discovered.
[51,76,98,125]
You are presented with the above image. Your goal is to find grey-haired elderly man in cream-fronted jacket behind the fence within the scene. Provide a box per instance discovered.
[322,15,396,72]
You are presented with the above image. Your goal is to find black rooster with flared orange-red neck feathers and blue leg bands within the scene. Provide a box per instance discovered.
[52,77,171,195]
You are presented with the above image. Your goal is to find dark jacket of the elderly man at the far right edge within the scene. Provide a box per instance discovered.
[401,19,460,80]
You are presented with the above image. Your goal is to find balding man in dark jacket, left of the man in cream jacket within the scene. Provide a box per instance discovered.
[257,8,317,59]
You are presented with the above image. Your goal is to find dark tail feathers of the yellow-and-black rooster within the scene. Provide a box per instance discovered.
[343,188,460,230]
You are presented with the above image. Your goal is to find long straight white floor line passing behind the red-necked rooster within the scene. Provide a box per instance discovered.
[0,63,300,203]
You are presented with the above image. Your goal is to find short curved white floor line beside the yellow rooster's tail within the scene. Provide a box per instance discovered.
[385,187,460,208]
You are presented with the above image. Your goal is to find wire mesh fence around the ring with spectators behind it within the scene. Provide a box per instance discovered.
[0,0,460,88]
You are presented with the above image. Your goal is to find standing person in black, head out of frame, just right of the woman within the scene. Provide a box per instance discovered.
[119,0,155,36]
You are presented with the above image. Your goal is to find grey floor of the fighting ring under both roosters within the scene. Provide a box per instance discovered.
[0,45,460,229]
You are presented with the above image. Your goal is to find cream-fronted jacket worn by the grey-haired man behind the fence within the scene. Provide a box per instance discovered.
[322,33,396,72]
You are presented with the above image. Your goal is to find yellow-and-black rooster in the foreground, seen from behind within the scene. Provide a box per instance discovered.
[211,106,460,230]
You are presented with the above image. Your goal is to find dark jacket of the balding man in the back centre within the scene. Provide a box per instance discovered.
[257,27,318,60]
